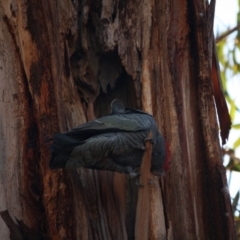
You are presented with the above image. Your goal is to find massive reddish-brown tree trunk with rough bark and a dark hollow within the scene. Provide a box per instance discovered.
[0,0,235,240]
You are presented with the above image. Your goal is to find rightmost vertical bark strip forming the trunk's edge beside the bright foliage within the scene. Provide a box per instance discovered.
[191,0,236,239]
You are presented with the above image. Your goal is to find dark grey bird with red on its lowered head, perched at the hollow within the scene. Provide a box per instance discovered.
[49,99,170,176]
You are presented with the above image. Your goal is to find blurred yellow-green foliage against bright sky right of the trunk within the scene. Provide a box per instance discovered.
[216,0,240,234]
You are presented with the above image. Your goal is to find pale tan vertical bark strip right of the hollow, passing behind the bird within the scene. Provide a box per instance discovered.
[141,1,166,239]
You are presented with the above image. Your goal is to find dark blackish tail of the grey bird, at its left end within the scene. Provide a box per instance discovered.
[49,133,82,169]
